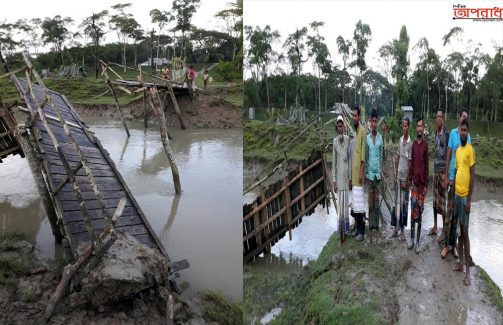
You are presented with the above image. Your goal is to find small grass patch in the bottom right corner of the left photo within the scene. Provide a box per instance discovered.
[199,291,243,325]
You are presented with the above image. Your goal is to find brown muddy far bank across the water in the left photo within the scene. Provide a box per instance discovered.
[74,93,243,129]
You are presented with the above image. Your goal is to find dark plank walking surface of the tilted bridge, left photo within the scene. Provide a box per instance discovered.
[14,78,167,257]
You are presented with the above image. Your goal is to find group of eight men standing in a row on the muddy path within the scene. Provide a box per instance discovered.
[332,106,475,285]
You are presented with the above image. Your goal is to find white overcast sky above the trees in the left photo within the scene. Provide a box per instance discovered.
[0,0,230,46]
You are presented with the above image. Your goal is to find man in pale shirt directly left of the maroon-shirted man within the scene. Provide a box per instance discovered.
[391,116,412,241]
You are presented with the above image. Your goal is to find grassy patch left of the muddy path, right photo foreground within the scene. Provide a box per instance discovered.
[260,234,403,324]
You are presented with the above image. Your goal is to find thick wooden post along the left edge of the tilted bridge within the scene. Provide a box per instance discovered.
[16,126,63,242]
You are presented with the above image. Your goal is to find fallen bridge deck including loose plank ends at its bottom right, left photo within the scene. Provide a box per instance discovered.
[7,75,189,291]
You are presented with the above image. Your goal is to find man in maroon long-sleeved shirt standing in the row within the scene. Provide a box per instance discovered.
[407,117,429,254]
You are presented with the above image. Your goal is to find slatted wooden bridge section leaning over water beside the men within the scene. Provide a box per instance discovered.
[243,150,329,263]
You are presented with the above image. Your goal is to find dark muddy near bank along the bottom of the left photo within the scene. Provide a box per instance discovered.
[0,234,242,324]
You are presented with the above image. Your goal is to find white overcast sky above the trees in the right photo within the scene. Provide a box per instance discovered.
[244,0,503,78]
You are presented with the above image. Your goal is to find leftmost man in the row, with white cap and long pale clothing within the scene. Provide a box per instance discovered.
[332,115,351,235]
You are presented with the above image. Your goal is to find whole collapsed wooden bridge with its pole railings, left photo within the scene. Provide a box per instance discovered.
[0,53,189,292]
